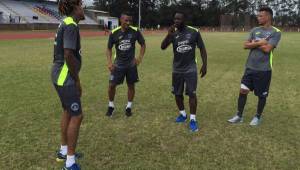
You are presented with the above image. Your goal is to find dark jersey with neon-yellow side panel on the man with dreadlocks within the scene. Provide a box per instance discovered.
[52,17,81,86]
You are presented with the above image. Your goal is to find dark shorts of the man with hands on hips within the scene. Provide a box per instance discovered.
[109,66,139,85]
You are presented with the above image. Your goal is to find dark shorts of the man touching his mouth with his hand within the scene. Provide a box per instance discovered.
[172,72,198,97]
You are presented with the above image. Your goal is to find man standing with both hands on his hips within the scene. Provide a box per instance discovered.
[106,13,146,117]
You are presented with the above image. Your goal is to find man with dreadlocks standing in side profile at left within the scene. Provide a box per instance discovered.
[51,0,85,170]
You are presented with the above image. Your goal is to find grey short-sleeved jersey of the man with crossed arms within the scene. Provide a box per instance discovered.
[246,27,281,71]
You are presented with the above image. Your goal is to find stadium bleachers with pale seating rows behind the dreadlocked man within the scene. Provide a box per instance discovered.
[0,0,97,25]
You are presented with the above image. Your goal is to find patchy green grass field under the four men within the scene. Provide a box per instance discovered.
[0,33,300,170]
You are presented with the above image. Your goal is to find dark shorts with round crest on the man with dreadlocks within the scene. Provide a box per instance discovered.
[54,85,82,116]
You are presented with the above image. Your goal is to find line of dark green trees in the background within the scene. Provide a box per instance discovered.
[93,0,300,27]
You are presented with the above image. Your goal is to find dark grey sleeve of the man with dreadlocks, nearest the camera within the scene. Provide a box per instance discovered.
[64,25,79,50]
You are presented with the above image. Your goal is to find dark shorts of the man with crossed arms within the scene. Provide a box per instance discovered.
[241,68,272,97]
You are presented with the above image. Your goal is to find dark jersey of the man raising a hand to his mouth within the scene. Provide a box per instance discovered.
[171,26,204,73]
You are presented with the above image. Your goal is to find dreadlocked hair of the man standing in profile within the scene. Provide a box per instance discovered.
[58,0,82,16]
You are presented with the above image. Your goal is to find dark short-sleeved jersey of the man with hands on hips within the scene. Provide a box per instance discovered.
[107,26,145,68]
